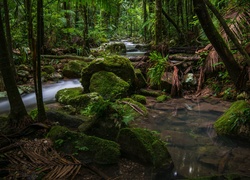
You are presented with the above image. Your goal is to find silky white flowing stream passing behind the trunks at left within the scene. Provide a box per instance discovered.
[0,79,81,114]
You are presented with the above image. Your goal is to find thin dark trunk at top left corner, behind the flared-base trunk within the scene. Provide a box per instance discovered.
[3,0,17,78]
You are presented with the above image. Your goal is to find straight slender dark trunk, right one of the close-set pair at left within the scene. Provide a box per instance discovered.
[36,0,47,122]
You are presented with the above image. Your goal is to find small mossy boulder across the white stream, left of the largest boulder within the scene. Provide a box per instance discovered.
[62,60,87,78]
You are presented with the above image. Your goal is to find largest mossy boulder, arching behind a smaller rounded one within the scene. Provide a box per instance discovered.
[81,55,135,92]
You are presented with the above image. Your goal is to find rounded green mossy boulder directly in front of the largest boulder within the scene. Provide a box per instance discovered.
[89,71,129,100]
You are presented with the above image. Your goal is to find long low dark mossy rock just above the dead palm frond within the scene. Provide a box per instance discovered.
[47,126,120,164]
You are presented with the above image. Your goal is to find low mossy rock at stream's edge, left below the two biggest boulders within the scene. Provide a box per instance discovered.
[55,87,103,108]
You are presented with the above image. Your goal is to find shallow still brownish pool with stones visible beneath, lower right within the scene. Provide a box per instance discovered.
[138,99,250,179]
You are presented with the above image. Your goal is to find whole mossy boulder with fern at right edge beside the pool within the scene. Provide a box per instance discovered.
[214,100,250,139]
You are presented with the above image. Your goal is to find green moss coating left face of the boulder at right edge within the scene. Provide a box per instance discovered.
[214,100,250,135]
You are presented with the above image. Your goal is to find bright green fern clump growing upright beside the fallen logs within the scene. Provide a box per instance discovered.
[147,51,168,85]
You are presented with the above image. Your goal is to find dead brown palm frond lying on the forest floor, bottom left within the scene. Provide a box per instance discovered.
[5,139,82,179]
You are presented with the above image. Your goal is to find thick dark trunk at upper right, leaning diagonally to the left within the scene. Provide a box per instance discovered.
[193,0,241,87]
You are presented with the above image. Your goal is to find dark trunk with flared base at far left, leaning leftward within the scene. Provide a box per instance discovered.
[0,7,28,128]
